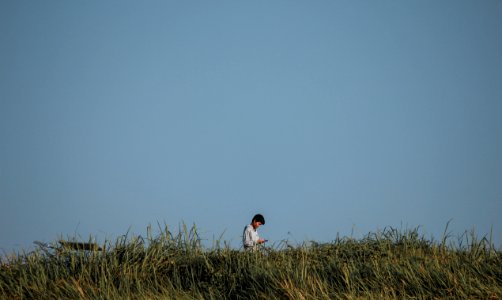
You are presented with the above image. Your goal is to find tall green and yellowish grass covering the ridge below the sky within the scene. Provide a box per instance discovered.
[0,226,502,299]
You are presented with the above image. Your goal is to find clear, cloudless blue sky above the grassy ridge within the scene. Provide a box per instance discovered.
[0,0,502,253]
